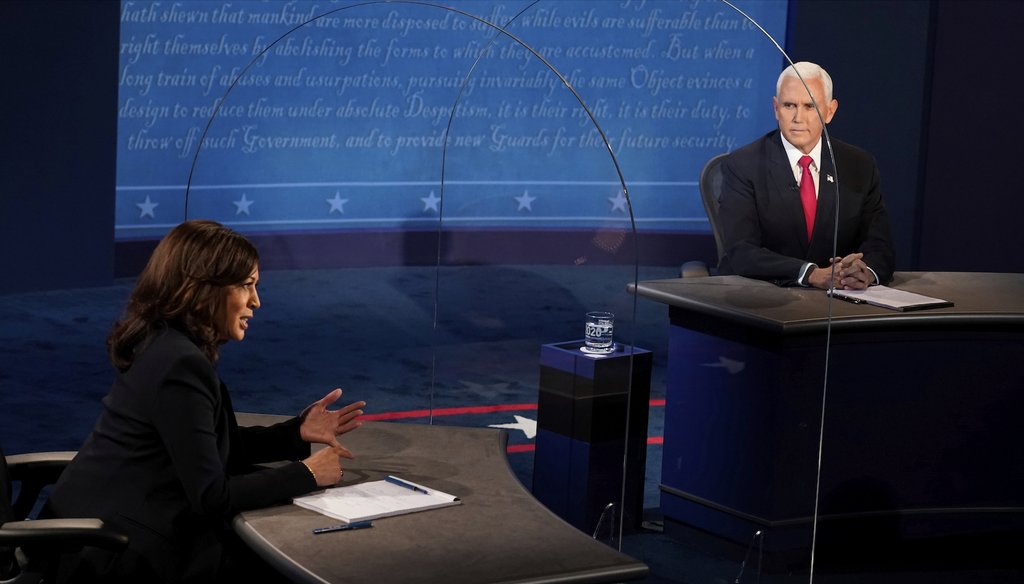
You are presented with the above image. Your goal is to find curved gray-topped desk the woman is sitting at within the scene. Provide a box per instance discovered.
[233,414,648,584]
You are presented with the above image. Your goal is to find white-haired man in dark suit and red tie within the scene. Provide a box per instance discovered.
[719,61,895,289]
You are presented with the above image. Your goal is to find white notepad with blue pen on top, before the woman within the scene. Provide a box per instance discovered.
[292,477,462,524]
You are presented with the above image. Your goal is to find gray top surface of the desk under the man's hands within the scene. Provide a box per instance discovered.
[629,272,1024,334]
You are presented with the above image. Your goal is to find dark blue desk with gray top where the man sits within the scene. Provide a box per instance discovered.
[630,273,1024,549]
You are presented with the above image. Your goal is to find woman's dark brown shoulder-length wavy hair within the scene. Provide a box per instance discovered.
[106,220,259,371]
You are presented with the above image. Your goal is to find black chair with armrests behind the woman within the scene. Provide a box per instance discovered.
[0,450,128,584]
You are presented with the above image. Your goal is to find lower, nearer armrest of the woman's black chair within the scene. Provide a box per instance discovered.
[0,518,128,551]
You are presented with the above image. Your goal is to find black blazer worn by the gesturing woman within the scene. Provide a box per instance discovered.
[47,327,316,582]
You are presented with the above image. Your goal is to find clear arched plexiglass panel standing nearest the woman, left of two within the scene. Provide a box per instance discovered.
[176,2,650,542]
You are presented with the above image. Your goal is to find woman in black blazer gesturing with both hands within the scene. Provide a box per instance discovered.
[48,221,366,582]
